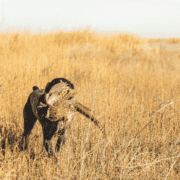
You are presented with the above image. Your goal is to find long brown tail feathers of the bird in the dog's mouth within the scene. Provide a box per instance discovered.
[73,102,106,137]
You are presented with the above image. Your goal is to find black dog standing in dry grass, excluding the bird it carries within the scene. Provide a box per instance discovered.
[20,78,74,156]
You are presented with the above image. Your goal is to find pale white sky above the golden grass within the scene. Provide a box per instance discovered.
[0,0,180,38]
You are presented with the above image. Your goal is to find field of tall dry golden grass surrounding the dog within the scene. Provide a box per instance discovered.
[0,29,180,180]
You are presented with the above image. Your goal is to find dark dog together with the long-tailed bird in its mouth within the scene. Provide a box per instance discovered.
[20,78,104,160]
